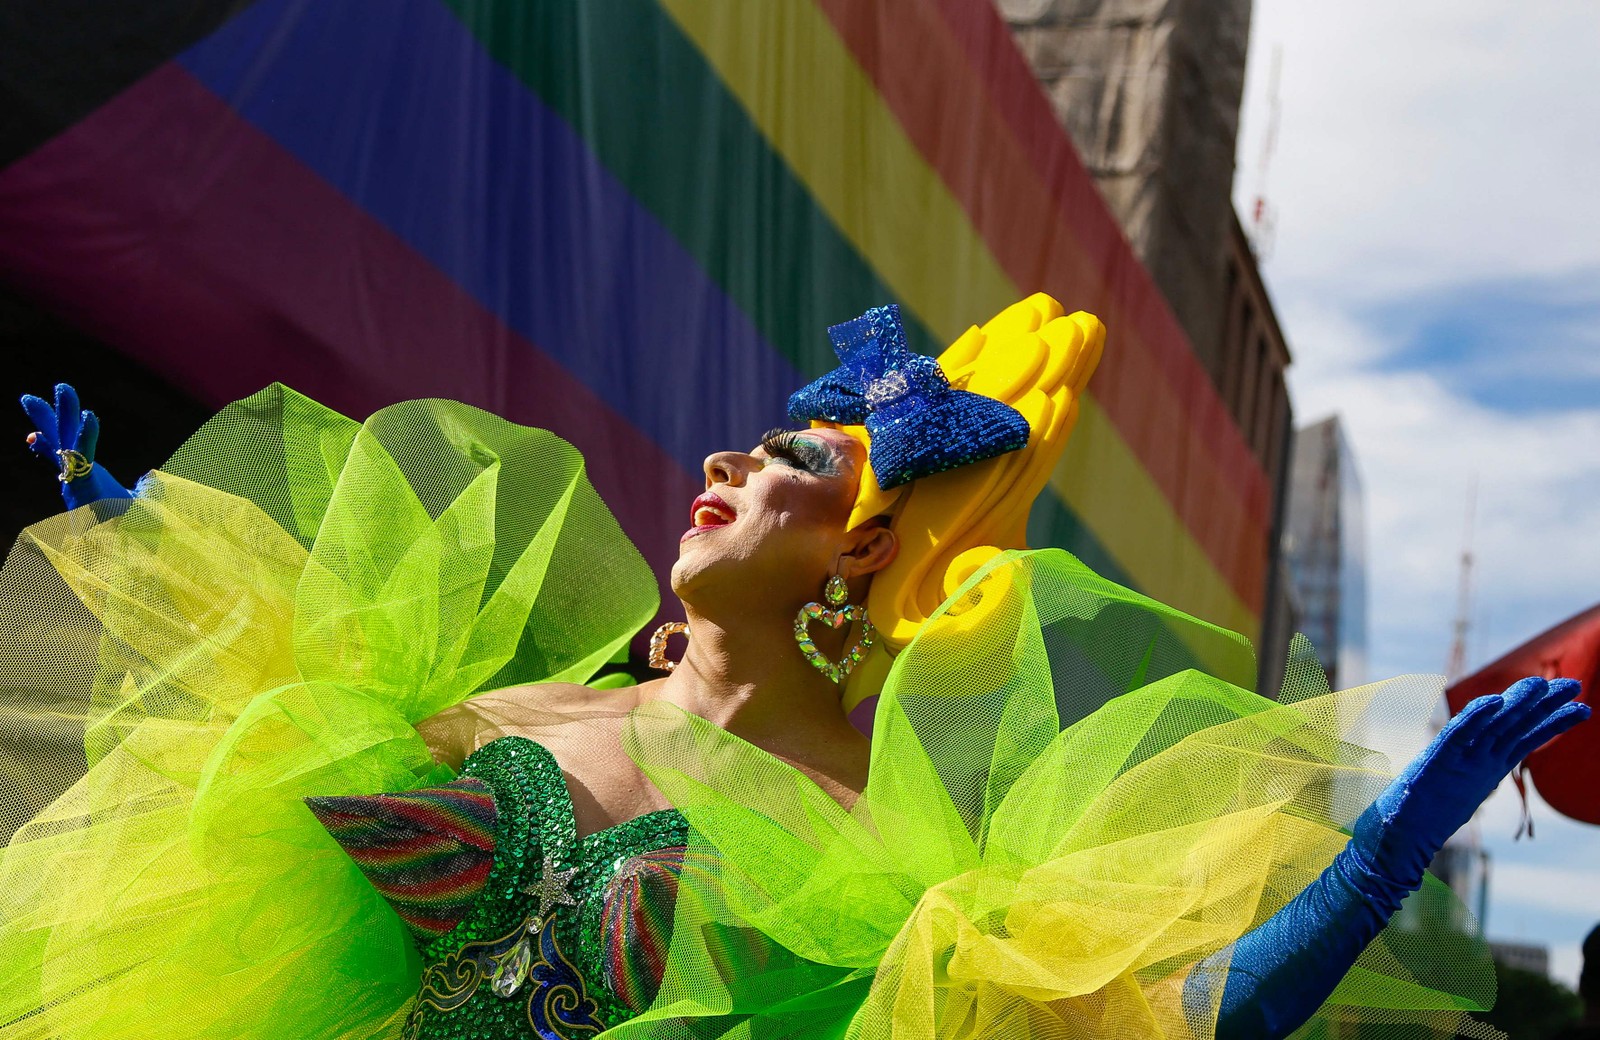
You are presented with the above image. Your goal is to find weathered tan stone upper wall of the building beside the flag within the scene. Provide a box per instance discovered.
[997,0,1250,382]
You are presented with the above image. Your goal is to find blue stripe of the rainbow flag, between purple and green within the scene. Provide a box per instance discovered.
[179,0,805,472]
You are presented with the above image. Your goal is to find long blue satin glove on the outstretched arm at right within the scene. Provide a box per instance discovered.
[1209,678,1589,1040]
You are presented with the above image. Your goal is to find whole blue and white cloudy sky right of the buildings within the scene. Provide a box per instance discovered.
[1235,0,1600,986]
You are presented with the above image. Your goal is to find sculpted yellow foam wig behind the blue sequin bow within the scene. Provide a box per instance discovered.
[814,293,1106,710]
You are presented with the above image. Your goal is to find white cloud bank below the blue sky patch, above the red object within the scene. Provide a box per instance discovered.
[1286,307,1600,677]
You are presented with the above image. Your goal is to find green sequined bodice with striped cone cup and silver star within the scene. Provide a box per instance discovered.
[405,736,688,1040]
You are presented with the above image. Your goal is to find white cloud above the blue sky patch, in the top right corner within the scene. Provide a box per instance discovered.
[1238,0,1600,294]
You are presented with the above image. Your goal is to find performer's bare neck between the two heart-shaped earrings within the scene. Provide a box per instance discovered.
[661,603,850,747]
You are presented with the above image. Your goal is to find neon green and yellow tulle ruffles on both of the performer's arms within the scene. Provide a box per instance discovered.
[0,387,1493,1040]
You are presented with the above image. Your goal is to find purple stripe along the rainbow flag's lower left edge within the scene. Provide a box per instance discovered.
[0,64,701,608]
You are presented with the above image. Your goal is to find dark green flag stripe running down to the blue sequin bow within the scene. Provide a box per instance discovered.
[445,0,942,374]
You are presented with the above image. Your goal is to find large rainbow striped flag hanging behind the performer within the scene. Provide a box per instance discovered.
[0,0,1270,675]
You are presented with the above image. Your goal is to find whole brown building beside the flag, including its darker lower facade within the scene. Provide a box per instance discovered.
[995,0,1298,694]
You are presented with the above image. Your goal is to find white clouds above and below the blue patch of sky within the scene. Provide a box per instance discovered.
[1238,0,1600,677]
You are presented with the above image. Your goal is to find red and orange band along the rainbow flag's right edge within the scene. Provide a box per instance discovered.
[816,0,1270,613]
